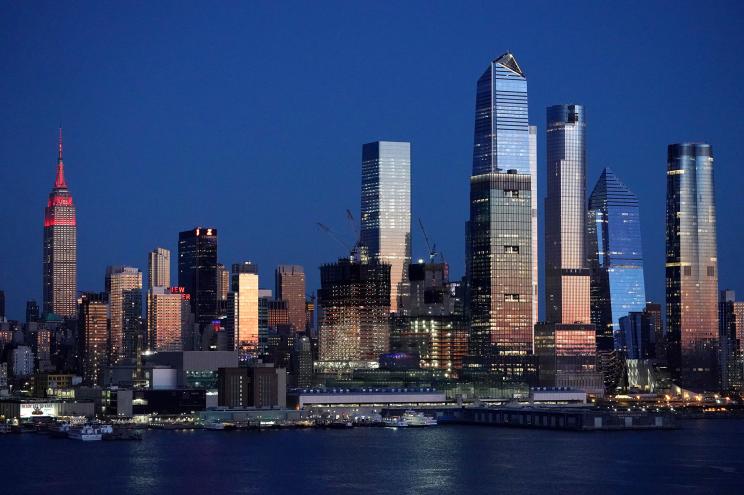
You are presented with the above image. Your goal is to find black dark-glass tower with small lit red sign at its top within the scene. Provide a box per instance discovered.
[178,227,218,338]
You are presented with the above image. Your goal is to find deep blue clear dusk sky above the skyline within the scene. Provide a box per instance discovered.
[0,1,744,319]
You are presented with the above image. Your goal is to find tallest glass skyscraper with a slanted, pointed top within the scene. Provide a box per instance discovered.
[466,53,536,371]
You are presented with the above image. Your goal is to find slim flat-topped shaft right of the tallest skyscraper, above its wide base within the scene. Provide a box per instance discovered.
[545,105,591,324]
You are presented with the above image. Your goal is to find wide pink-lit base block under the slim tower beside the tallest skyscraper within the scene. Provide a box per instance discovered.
[535,322,604,395]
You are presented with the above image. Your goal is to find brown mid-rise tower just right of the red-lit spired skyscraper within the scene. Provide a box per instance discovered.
[78,292,110,386]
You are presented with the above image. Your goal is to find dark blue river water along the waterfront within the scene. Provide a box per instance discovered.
[0,420,744,495]
